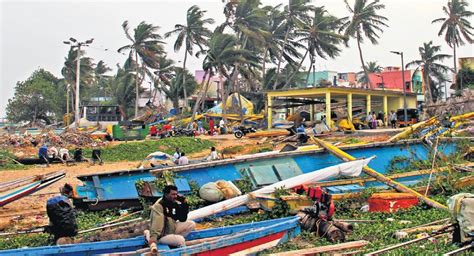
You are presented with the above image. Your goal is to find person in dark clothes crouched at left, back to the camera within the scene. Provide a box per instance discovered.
[46,183,78,244]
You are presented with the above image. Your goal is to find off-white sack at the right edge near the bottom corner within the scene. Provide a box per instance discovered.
[448,193,474,243]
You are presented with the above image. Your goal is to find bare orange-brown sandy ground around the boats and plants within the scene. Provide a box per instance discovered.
[0,134,389,230]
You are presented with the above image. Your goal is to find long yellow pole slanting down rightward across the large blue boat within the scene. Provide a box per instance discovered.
[311,136,448,210]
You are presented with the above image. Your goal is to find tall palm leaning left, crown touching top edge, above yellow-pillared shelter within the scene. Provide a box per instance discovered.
[341,0,388,89]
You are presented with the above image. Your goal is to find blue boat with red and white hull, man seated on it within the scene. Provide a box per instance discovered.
[0,217,301,256]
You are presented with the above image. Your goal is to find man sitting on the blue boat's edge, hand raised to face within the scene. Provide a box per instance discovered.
[149,185,196,247]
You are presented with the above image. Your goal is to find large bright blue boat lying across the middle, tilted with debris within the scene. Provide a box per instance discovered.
[74,140,462,210]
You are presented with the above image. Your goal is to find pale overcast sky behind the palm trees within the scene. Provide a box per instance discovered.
[0,0,474,117]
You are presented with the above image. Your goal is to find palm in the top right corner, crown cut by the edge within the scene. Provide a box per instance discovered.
[431,0,474,77]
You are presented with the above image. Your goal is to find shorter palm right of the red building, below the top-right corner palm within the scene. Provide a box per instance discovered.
[406,41,451,104]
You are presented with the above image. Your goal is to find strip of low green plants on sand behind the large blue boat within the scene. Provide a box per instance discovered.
[84,137,214,162]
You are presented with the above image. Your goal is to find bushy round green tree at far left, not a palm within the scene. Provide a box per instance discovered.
[6,69,66,125]
